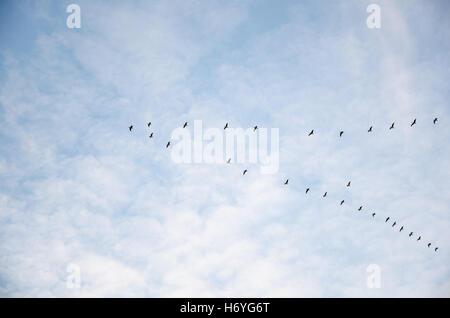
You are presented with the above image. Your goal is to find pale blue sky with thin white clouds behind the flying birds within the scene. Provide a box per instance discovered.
[0,0,450,297]
